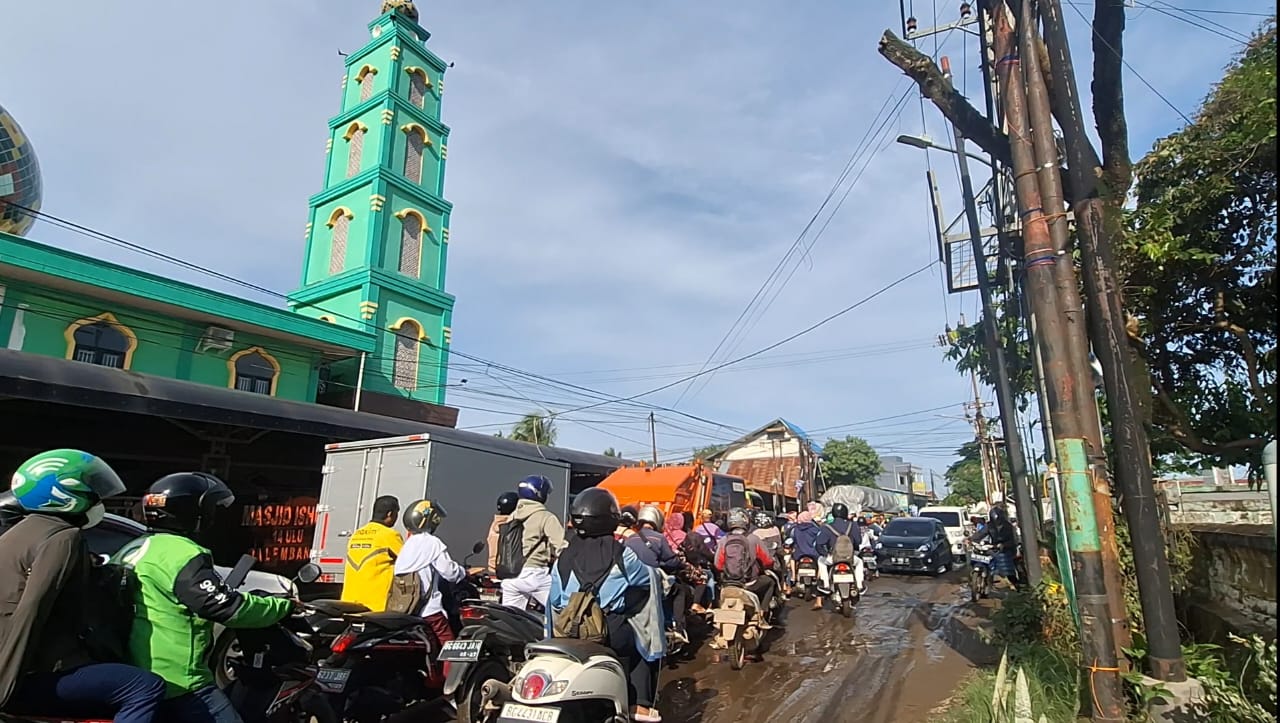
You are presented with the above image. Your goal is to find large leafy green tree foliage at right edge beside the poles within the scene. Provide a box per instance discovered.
[1116,19,1276,465]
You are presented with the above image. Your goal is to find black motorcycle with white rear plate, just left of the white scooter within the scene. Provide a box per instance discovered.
[438,543,545,723]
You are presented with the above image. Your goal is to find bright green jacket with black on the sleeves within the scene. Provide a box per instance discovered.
[114,532,293,697]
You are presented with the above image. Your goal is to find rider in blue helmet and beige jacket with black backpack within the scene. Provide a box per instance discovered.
[494,475,564,610]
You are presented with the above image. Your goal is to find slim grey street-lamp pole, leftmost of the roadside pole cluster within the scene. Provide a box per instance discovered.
[942,58,1041,586]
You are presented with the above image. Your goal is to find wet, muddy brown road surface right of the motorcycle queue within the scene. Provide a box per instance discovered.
[658,572,991,723]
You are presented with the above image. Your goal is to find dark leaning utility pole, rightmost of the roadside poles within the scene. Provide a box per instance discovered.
[1028,0,1187,681]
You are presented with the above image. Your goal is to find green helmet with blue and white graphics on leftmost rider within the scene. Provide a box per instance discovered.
[10,449,124,514]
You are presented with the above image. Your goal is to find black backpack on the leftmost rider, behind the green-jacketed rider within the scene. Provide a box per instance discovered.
[82,563,140,663]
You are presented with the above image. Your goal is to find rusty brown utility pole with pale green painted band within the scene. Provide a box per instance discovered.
[995,0,1125,723]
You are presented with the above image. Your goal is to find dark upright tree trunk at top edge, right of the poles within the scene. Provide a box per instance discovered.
[1093,0,1133,203]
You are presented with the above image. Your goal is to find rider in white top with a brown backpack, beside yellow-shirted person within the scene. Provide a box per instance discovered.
[387,499,467,645]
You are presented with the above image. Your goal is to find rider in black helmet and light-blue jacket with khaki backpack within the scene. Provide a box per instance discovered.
[547,488,666,723]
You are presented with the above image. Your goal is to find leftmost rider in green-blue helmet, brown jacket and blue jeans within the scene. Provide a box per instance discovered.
[0,449,165,723]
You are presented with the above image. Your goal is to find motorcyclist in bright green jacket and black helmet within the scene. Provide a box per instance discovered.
[115,472,296,723]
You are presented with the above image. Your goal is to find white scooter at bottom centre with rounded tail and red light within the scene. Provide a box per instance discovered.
[481,637,631,723]
